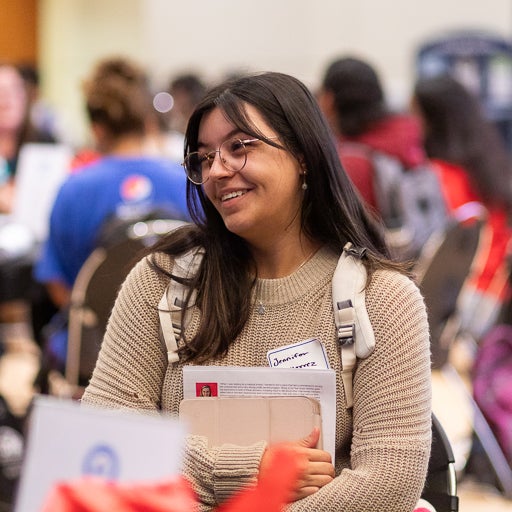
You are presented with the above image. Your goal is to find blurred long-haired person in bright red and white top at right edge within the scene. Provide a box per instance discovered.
[411,75,512,338]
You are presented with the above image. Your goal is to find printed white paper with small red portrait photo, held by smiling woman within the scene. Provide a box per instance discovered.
[183,366,336,461]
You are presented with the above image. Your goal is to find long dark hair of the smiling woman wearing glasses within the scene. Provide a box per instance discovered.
[150,73,401,362]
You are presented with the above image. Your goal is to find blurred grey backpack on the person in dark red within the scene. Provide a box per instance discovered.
[343,142,449,260]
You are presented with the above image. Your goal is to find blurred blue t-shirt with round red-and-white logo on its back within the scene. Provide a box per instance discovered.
[34,157,189,288]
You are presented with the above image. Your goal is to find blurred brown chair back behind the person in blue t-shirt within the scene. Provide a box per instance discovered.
[65,218,185,389]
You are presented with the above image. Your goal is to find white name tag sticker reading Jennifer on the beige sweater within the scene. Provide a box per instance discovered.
[267,338,330,370]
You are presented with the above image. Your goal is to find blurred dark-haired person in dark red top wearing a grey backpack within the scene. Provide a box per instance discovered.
[317,56,425,209]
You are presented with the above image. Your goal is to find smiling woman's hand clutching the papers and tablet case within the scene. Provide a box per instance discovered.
[260,428,334,501]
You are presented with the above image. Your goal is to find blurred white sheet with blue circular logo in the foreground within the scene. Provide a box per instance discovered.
[15,396,185,512]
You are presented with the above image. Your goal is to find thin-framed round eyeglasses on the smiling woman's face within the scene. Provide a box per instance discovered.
[182,137,266,185]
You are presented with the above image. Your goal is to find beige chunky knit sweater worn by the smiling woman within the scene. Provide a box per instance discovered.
[82,248,431,512]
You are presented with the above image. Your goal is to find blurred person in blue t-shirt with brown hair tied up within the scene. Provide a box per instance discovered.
[34,58,189,372]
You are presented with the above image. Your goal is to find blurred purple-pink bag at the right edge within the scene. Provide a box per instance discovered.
[473,325,512,466]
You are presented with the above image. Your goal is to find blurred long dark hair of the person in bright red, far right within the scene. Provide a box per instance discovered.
[413,75,512,211]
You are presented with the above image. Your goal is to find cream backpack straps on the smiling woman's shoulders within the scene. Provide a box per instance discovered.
[158,243,375,408]
